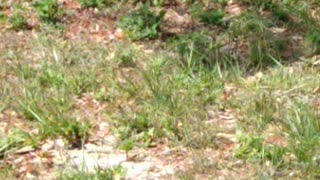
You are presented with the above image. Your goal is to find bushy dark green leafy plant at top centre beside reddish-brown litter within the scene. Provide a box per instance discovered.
[117,5,165,40]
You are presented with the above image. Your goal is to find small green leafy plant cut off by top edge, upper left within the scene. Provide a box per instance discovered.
[34,0,63,23]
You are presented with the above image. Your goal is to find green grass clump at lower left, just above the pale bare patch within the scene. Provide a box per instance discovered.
[20,87,90,147]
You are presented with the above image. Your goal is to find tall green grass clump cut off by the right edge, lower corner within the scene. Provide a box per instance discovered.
[281,102,320,174]
